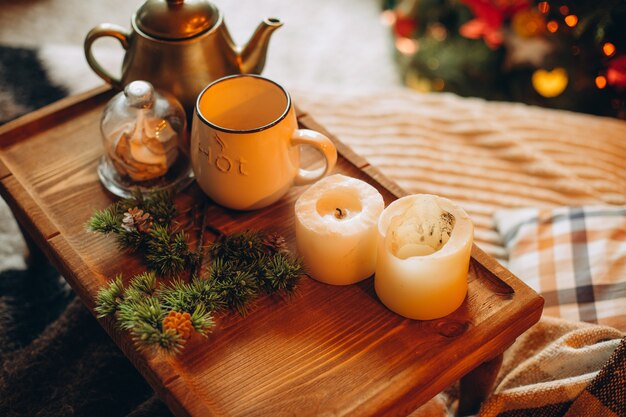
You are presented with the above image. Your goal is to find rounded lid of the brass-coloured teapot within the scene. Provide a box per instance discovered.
[134,0,220,40]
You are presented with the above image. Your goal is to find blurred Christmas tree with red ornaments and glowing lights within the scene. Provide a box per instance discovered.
[382,0,626,119]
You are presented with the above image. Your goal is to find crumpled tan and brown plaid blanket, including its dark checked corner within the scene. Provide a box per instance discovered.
[478,317,626,417]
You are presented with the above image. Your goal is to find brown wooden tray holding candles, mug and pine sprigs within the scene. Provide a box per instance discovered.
[0,88,543,416]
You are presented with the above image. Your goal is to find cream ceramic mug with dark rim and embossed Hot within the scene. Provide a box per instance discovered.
[191,74,337,210]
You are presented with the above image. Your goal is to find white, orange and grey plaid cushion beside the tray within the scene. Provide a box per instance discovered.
[494,205,626,332]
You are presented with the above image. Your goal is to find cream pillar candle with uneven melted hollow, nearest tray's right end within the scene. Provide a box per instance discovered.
[374,194,474,320]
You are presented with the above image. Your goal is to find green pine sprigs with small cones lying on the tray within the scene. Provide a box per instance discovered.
[87,193,302,354]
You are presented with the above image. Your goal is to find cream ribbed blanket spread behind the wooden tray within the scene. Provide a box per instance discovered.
[293,89,626,260]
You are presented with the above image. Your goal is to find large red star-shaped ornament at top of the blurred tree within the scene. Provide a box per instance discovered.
[459,0,530,49]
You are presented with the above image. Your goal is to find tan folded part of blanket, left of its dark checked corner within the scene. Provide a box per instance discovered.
[478,317,622,417]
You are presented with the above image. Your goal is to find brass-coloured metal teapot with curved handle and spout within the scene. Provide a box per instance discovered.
[85,0,282,116]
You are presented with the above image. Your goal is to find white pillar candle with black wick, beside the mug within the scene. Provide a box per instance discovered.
[295,174,385,285]
